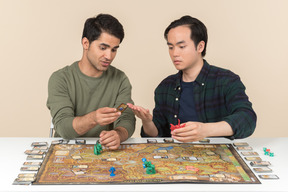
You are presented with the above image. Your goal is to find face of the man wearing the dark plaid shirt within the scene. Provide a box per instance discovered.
[167,26,202,71]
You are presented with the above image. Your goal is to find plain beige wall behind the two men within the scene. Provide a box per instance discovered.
[0,0,288,137]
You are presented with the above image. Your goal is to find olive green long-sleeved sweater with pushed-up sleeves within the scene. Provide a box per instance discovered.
[47,61,135,139]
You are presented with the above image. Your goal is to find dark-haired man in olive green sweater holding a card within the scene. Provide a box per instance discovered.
[47,14,135,149]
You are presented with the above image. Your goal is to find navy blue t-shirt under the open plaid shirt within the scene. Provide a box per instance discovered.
[178,80,198,123]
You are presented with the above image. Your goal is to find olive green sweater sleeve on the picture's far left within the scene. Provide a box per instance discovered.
[47,72,79,139]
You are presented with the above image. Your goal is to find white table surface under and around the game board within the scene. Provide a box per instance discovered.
[0,137,288,192]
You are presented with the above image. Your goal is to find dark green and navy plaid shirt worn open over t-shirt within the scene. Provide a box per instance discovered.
[141,60,257,139]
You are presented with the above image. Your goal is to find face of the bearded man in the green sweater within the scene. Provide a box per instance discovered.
[86,32,120,76]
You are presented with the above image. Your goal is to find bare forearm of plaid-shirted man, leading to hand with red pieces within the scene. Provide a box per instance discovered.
[204,121,234,137]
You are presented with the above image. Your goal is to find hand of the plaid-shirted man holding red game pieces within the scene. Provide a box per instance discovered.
[171,121,207,143]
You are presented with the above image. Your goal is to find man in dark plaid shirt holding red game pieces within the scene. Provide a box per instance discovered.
[128,16,257,142]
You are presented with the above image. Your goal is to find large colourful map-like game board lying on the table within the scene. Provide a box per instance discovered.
[33,143,260,185]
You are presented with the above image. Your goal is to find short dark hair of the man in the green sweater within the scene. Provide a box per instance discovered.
[82,14,124,43]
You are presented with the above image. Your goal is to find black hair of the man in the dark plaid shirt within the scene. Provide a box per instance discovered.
[164,15,208,57]
